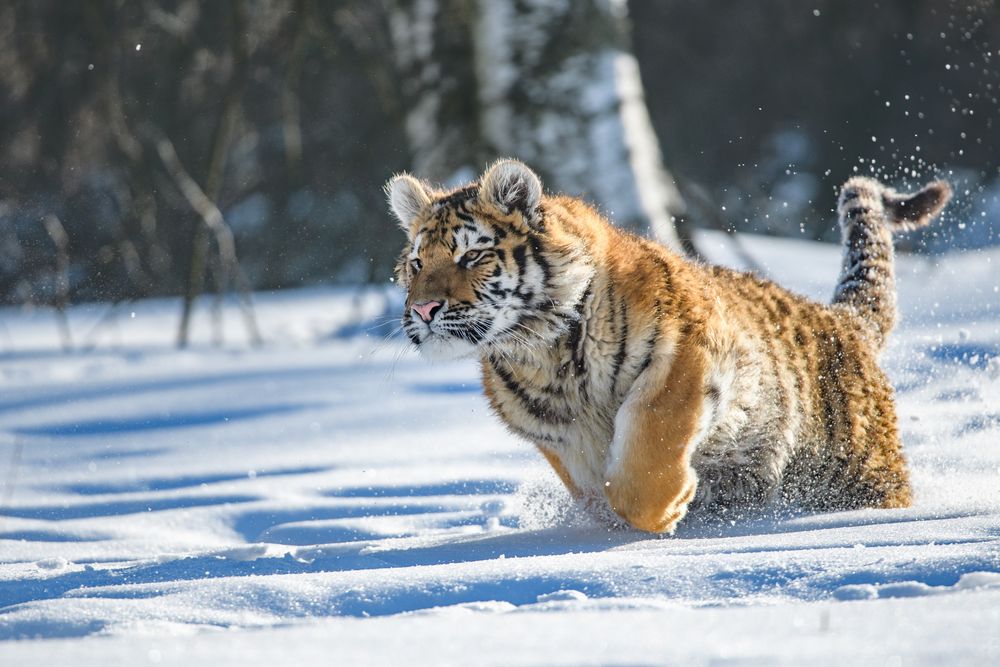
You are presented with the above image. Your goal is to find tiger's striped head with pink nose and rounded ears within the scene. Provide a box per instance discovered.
[385,160,593,359]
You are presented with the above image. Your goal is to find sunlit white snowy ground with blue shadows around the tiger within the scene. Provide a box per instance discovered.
[0,236,1000,665]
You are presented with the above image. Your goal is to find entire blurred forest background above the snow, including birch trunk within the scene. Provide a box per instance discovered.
[0,0,1000,338]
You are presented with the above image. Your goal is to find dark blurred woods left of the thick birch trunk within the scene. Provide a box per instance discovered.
[0,0,410,314]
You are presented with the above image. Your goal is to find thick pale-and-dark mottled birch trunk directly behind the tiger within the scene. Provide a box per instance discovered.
[380,0,684,250]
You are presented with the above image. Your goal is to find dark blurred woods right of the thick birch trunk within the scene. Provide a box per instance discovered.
[629,0,1000,249]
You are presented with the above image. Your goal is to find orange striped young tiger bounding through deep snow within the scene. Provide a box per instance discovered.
[385,159,951,534]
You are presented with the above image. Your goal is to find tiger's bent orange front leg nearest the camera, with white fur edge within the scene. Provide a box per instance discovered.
[604,347,705,533]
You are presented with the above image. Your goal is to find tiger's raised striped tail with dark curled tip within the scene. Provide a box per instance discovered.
[833,176,951,350]
